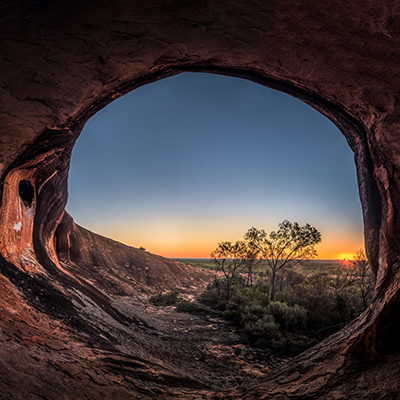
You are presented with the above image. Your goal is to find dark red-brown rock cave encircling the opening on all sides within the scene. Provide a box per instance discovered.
[0,0,400,399]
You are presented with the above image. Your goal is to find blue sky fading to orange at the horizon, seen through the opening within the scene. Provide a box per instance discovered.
[67,73,364,259]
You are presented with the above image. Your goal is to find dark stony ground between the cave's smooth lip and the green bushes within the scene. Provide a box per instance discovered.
[112,293,286,389]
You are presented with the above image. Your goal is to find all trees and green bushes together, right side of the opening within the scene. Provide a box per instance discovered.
[202,221,374,355]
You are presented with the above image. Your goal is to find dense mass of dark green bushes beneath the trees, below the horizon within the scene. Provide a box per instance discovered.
[202,265,374,355]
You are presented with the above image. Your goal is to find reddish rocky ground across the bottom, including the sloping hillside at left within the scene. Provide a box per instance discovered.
[0,224,400,400]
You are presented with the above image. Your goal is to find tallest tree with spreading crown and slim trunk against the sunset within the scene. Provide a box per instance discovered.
[244,220,321,301]
